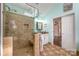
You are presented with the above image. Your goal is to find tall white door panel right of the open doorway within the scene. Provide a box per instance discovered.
[62,14,75,50]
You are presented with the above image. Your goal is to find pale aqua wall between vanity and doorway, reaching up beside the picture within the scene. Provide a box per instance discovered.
[46,3,63,43]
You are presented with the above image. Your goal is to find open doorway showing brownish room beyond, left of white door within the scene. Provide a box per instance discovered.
[53,17,62,47]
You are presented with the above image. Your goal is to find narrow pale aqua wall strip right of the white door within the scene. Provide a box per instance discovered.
[74,3,79,51]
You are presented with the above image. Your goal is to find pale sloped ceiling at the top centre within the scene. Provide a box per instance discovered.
[11,3,54,17]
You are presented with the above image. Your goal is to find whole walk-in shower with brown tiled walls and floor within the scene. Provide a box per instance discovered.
[3,4,38,56]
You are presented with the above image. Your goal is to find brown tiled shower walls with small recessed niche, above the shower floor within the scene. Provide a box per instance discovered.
[4,12,34,52]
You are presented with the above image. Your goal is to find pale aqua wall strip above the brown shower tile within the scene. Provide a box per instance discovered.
[4,3,36,17]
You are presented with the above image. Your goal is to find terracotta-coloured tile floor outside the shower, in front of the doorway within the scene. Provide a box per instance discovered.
[41,44,76,56]
